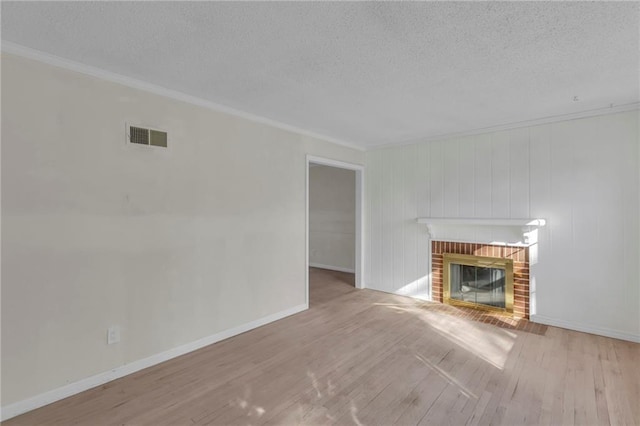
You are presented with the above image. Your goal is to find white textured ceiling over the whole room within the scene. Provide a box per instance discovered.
[2,1,640,147]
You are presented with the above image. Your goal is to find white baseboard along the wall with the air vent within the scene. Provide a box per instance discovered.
[0,304,309,421]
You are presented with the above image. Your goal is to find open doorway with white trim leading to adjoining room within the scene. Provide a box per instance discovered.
[306,156,364,306]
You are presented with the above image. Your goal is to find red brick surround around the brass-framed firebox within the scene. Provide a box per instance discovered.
[431,241,529,319]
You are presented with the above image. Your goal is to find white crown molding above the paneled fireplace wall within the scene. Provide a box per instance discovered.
[367,102,640,151]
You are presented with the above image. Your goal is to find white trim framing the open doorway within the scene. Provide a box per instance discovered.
[305,154,365,306]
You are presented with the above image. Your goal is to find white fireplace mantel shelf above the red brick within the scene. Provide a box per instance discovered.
[417,217,547,245]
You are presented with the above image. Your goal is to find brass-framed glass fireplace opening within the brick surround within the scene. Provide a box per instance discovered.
[443,253,513,313]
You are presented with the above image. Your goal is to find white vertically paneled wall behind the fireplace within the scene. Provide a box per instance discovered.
[365,111,640,340]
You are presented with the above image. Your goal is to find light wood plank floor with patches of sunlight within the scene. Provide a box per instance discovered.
[5,269,640,426]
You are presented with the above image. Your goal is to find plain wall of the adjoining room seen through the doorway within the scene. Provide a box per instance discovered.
[309,165,356,272]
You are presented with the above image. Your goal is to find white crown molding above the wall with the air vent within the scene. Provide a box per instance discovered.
[0,40,365,151]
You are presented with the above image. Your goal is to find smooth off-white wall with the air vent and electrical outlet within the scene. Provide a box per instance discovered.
[2,54,364,407]
